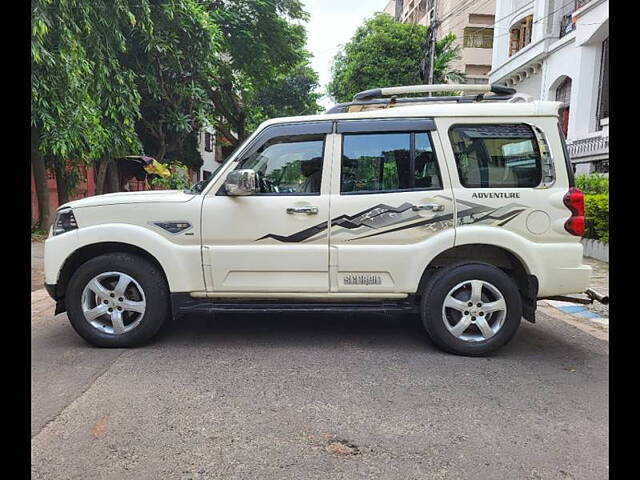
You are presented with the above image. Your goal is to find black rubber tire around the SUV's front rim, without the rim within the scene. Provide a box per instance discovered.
[65,253,171,348]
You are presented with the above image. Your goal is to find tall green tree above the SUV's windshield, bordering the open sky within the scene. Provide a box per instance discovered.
[207,0,317,145]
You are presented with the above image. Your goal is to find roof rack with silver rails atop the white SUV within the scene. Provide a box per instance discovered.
[325,84,531,113]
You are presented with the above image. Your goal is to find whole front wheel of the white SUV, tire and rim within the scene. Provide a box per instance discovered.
[65,253,170,347]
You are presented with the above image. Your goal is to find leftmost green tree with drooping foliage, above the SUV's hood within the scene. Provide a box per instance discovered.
[31,0,149,221]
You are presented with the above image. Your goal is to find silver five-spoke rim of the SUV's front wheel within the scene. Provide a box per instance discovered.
[81,272,147,335]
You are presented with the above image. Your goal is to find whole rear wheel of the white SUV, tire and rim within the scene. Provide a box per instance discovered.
[421,263,522,356]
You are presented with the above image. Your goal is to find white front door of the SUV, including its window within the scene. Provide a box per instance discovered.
[202,122,332,293]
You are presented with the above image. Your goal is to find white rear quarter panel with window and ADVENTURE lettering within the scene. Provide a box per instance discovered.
[439,117,575,245]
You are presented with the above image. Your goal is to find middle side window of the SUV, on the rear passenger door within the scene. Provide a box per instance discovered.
[340,133,441,193]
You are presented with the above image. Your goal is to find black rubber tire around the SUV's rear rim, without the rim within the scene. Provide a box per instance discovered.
[420,262,522,357]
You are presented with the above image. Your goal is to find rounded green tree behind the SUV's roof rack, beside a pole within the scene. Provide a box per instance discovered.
[327,13,464,102]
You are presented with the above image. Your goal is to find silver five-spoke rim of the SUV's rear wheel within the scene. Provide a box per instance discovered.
[442,280,507,342]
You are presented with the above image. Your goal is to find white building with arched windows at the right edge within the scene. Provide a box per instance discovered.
[489,0,609,173]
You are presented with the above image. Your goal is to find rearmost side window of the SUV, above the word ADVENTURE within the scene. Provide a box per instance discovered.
[449,124,542,188]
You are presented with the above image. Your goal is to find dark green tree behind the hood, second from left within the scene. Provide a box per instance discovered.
[125,0,221,163]
